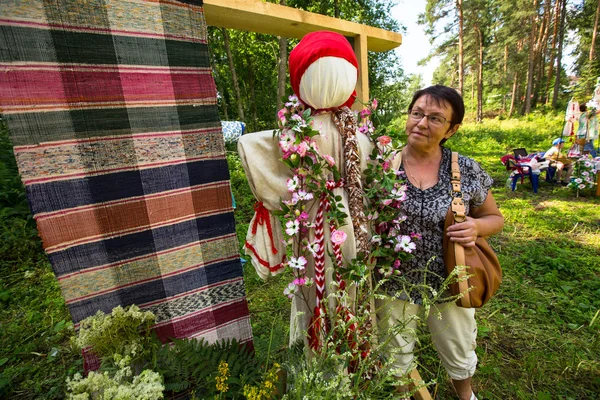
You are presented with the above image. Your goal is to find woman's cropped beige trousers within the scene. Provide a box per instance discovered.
[376,298,477,380]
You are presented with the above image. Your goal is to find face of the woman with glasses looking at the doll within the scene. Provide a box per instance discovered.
[406,94,459,151]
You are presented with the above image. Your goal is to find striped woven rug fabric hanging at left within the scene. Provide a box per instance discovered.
[0,0,252,366]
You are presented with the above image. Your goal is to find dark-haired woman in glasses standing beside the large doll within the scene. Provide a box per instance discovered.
[377,85,504,399]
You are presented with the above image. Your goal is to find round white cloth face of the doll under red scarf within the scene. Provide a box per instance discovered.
[300,57,357,109]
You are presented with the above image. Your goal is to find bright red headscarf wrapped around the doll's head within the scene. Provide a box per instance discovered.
[289,31,358,107]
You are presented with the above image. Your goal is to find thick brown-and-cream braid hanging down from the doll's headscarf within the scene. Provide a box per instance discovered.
[331,107,368,253]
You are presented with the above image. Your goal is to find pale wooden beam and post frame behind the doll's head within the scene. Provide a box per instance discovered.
[204,0,402,109]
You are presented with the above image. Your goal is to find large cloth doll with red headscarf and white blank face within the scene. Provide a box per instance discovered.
[238,31,373,348]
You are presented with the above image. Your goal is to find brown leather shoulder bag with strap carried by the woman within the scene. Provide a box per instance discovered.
[443,152,502,308]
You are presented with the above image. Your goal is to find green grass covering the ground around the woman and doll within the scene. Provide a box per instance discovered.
[0,115,600,399]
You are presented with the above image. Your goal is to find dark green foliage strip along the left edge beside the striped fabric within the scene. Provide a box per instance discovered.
[0,122,82,399]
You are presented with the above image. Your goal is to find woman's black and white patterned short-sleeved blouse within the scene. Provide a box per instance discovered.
[382,147,493,304]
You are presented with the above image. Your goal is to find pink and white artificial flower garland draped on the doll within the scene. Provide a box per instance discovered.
[274,96,418,306]
